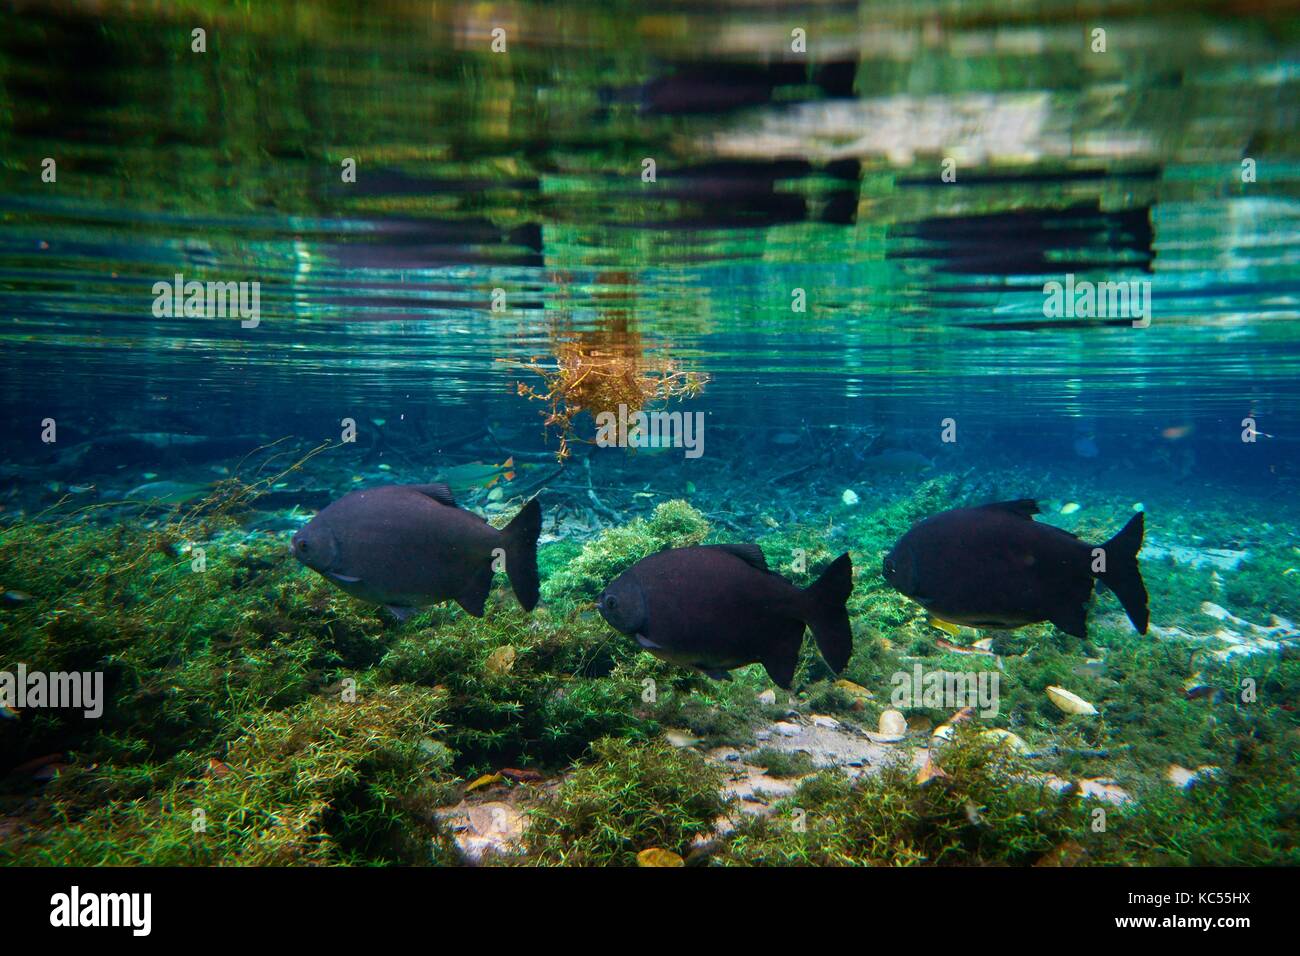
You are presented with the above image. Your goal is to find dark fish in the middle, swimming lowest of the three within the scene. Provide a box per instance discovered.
[597,545,853,688]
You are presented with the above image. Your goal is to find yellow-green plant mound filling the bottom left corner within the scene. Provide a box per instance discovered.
[0,685,449,865]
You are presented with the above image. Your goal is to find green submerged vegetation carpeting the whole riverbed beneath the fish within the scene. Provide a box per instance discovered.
[0,476,1300,865]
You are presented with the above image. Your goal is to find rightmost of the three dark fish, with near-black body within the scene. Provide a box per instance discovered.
[884,498,1149,637]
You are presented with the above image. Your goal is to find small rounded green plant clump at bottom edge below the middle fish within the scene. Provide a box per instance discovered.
[514,737,727,866]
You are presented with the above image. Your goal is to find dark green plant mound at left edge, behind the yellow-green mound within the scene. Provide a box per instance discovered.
[0,515,386,770]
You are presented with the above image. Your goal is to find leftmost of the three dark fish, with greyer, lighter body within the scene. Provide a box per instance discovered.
[293,485,542,620]
